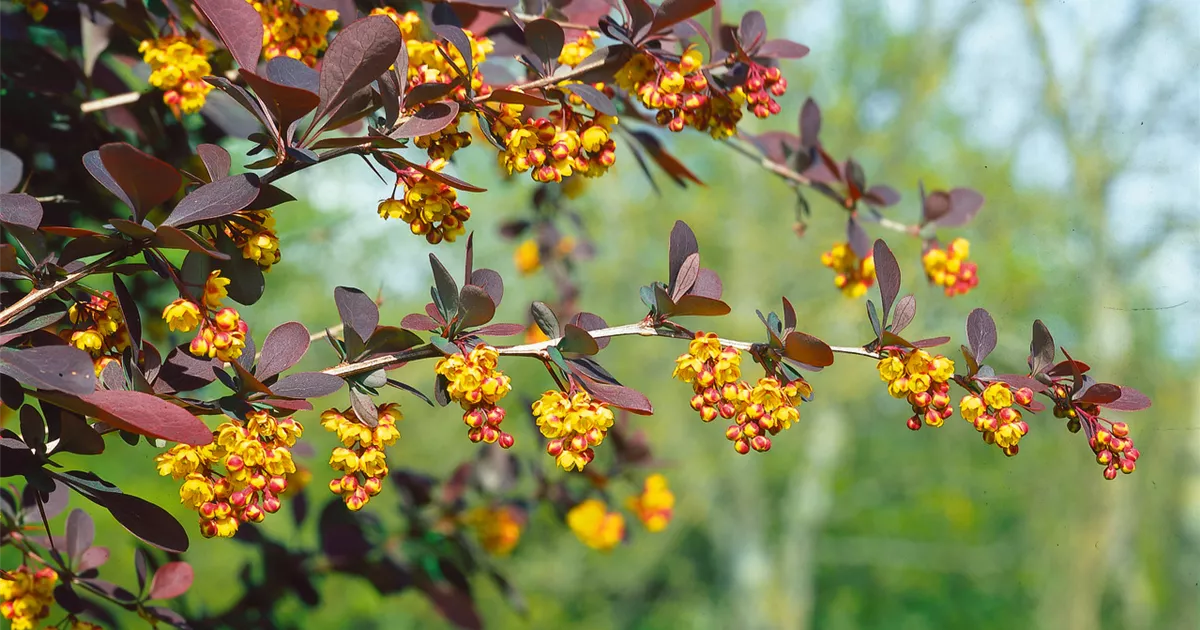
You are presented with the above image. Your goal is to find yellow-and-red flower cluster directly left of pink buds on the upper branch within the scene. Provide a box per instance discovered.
[617,47,748,140]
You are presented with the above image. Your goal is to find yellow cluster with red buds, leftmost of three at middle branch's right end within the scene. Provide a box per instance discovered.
[876,348,954,431]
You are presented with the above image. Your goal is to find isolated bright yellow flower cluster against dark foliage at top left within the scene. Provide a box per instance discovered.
[138,35,214,115]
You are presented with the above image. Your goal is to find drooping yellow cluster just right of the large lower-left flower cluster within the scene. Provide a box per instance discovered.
[320,403,404,511]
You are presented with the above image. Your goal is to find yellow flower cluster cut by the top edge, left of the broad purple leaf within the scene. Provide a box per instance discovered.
[246,0,337,67]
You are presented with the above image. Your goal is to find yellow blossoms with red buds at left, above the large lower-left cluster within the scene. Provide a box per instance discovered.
[162,271,250,362]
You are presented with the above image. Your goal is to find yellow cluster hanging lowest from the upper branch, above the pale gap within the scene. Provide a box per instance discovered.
[379,160,470,245]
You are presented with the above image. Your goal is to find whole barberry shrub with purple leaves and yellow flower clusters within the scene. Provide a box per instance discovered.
[0,0,1150,629]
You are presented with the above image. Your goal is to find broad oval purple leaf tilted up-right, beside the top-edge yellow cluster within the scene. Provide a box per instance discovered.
[319,16,401,119]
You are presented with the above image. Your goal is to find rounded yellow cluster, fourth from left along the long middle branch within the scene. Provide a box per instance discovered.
[533,389,613,470]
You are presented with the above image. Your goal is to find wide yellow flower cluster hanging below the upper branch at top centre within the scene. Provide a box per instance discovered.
[488,103,617,182]
